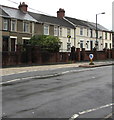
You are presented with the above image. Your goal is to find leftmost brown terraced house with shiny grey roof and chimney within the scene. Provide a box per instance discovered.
[0,3,37,51]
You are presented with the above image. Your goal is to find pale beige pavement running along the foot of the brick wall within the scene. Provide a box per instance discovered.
[0,61,114,76]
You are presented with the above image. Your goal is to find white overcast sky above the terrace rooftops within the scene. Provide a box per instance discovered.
[1,0,114,30]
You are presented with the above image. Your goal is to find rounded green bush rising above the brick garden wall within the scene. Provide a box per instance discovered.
[30,35,61,52]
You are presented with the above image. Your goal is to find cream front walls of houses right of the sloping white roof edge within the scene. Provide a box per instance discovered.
[75,27,112,50]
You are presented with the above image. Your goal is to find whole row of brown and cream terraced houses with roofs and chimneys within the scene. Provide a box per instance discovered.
[0,2,112,52]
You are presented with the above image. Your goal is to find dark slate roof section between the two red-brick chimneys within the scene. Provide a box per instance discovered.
[29,12,75,28]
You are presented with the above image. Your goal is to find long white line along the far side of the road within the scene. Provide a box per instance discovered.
[0,66,109,85]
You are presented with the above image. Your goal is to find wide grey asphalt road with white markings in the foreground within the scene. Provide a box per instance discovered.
[2,66,114,120]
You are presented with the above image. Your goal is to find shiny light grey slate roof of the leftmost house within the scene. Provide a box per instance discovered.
[2,6,37,22]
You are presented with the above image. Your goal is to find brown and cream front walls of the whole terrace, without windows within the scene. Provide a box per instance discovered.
[2,7,112,52]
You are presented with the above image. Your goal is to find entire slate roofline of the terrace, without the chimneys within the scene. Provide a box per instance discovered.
[0,5,109,31]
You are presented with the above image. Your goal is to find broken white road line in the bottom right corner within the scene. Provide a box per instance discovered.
[69,103,114,120]
